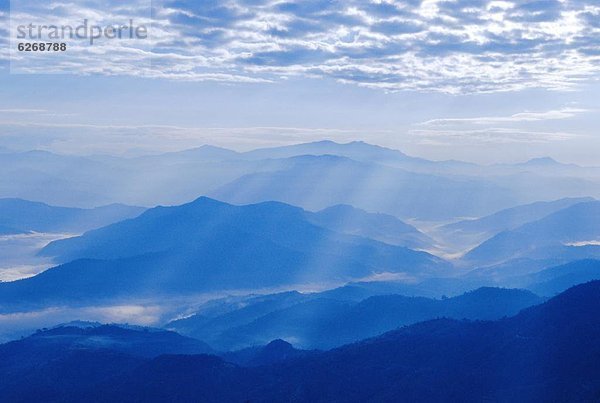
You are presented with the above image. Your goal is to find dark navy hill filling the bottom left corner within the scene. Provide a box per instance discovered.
[0,325,212,402]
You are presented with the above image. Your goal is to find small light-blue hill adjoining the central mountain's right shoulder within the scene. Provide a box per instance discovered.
[307,205,435,249]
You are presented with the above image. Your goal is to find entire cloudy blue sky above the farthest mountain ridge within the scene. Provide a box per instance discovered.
[0,0,600,165]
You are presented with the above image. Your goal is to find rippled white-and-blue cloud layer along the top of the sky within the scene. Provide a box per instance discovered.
[3,0,600,93]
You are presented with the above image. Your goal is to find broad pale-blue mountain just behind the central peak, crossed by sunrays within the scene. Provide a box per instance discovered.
[210,155,518,220]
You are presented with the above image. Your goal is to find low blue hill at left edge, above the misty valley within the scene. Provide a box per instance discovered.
[0,199,145,233]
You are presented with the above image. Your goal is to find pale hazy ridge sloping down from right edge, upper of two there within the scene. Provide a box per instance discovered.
[439,197,594,251]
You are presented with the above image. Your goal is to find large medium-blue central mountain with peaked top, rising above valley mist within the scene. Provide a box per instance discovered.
[0,198,450,306]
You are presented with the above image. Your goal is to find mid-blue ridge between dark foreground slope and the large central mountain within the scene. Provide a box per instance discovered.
[167,260,600,349]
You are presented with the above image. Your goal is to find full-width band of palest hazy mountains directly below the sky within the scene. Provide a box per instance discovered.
[0,141,600,220]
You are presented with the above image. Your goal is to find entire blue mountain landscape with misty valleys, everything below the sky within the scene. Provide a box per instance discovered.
[0,141,600,402]
